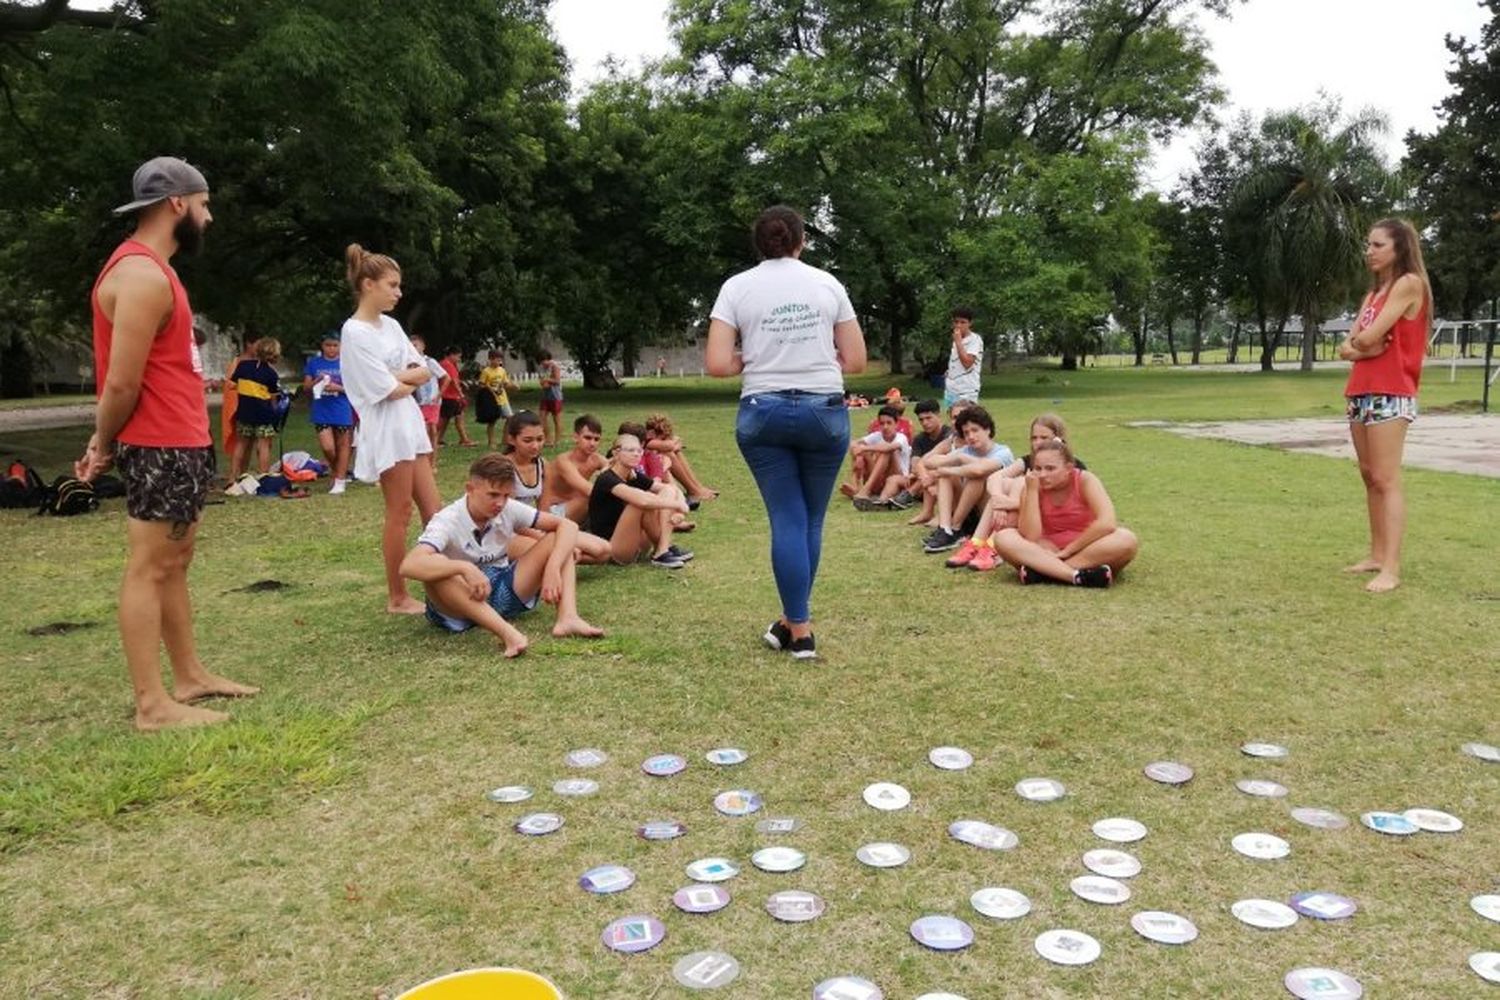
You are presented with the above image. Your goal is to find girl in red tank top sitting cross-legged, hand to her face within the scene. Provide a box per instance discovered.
[995,438,1140,586]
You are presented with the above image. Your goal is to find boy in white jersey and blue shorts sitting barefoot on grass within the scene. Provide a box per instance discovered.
[401,454,605,658]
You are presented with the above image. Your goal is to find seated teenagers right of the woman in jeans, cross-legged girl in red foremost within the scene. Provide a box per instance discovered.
[839,400,1140,588]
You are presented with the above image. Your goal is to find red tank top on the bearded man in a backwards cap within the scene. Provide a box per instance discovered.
[89,240,213,448]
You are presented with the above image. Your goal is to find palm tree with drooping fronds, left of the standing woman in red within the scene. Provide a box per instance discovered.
[1236,103,1398,372]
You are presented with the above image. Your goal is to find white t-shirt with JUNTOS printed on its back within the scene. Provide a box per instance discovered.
[710,256,855,396]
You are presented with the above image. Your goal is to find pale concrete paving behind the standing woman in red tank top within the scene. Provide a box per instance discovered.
[1131,414,1500,478]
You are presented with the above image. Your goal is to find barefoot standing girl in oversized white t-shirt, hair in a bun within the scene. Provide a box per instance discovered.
[339,243,440,615]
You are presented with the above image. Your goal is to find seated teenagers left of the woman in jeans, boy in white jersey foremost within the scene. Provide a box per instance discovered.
[401,409,719,657]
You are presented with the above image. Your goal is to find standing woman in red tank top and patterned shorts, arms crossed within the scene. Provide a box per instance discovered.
[1338,219,1433,594]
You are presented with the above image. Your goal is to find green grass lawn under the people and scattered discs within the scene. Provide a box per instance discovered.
[0,369,1500,1000]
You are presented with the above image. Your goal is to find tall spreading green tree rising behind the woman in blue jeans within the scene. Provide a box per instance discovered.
[671,0,1229,370]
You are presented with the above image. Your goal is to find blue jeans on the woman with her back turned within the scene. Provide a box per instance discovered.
[735,390,849,624]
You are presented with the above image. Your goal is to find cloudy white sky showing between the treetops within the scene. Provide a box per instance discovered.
[552,0,1485,187]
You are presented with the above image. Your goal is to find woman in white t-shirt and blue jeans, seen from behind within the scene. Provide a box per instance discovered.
[705,205,866,660]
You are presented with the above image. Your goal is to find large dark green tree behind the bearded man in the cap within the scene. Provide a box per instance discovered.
[0,0,569,395]
